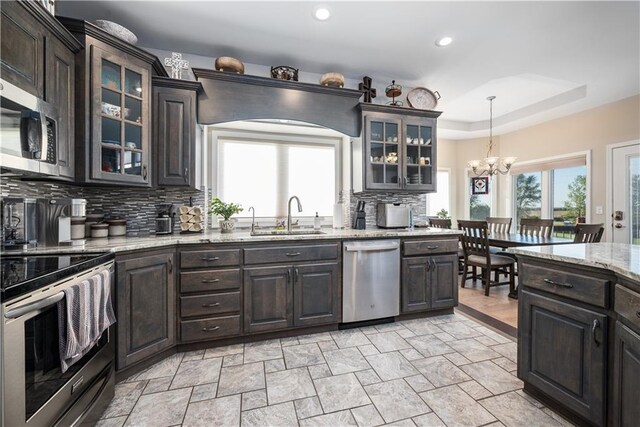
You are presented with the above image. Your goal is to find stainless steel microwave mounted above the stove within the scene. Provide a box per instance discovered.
[0,79,59,175]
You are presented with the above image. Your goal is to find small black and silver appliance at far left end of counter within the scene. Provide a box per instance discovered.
[0,197,38,250]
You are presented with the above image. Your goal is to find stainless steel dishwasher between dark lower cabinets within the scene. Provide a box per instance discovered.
[342,239,400,323]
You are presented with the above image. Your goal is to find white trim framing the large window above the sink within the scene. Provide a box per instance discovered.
[207,127,343,228]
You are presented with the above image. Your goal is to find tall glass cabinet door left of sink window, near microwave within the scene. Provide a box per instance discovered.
[92,46,150,183]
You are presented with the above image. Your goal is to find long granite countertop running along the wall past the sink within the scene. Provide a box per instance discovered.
[2,228,460,255]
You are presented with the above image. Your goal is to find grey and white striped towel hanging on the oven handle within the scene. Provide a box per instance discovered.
[58,270,116,372]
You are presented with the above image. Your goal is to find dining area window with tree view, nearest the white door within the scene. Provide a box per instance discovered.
[512,154,589,238]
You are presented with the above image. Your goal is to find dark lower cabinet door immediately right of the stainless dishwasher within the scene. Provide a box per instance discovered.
[400,257,431,313]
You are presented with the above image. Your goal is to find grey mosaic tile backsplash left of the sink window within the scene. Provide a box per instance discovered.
[0,177,205,236]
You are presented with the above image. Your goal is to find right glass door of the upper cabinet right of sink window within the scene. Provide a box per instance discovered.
[404,118,435,190]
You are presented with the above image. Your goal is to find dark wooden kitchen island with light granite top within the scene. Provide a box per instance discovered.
[509,243,640,426]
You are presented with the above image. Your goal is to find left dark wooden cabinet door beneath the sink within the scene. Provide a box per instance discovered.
[244,266,293,333]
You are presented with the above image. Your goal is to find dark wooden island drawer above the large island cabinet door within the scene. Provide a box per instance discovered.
[518,262,611,308]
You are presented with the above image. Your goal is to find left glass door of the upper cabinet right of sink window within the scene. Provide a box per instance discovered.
[365,117,401,189]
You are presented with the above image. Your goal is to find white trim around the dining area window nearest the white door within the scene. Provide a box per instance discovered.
[507,150,591,223]
